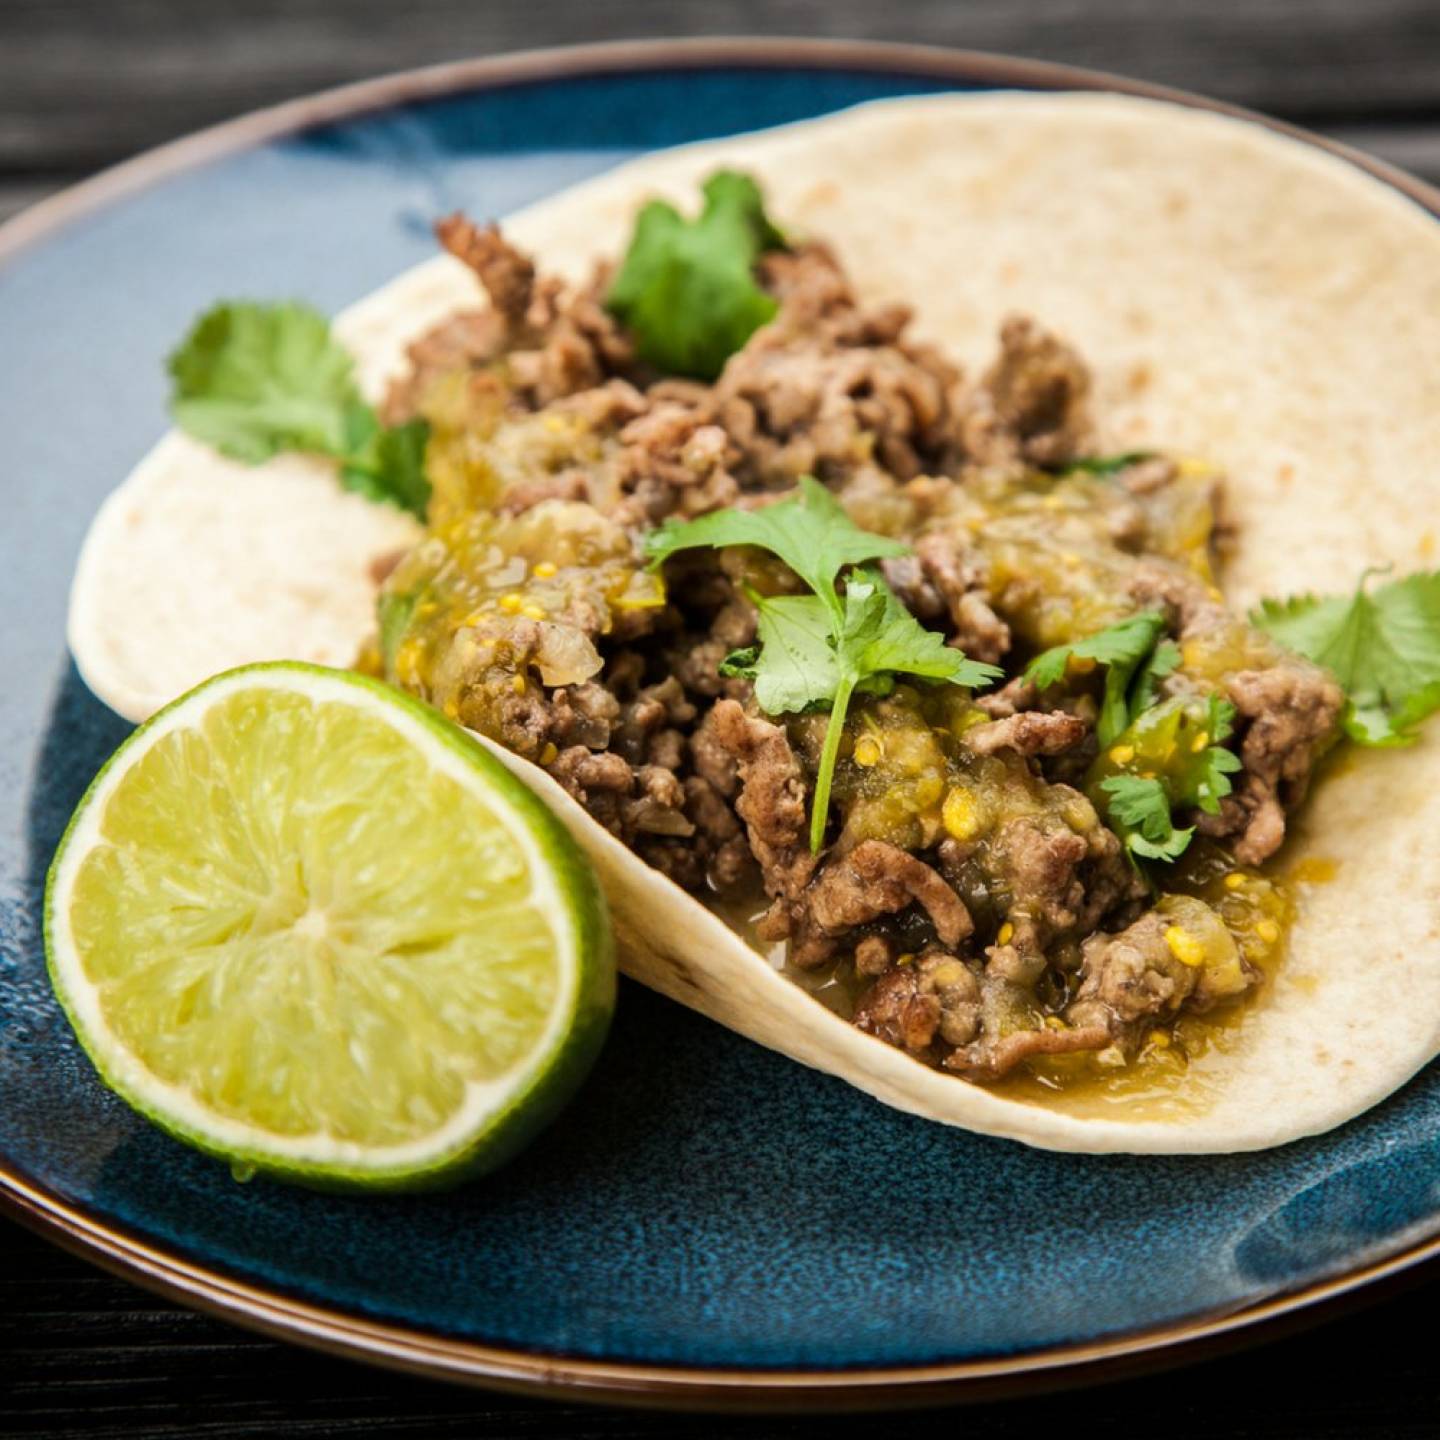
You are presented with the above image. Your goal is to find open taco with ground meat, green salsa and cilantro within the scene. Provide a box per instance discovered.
[71,94,1440,1152]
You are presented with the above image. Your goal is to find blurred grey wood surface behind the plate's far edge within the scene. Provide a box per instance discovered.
[0,0,1440,215]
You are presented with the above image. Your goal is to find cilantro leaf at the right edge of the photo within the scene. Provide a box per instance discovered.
[1250,570,1440,746]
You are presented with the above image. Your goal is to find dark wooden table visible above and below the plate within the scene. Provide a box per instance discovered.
[0,0,1440,1440]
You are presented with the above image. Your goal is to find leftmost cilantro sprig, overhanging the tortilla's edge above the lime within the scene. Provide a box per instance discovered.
[168,301,431,520]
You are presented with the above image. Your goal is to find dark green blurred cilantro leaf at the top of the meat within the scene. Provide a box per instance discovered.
[605,170,785,380]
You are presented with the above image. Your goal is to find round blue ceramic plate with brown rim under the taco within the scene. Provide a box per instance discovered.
[0,42,1440,1404]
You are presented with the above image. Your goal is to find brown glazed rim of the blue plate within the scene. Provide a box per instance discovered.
[11,36,1440,1413]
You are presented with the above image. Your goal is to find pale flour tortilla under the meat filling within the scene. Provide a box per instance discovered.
[71,94,1440,1152]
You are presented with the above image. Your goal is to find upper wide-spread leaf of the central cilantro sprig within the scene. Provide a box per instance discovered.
[645,475,909,631]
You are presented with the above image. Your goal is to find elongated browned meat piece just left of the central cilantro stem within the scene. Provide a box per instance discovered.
[708,700,815,897]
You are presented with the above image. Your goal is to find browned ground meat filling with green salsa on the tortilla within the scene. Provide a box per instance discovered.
[376,216,1344,1081]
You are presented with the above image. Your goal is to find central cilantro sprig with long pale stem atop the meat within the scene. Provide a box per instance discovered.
[647,477,1002,851]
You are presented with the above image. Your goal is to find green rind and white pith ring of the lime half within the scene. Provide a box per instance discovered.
[45,661,615,1189]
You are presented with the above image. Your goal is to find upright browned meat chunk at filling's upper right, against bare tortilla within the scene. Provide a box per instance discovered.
[962,315,1090,465]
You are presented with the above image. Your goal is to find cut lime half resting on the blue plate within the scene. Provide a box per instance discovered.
[45,664,615,1188]
